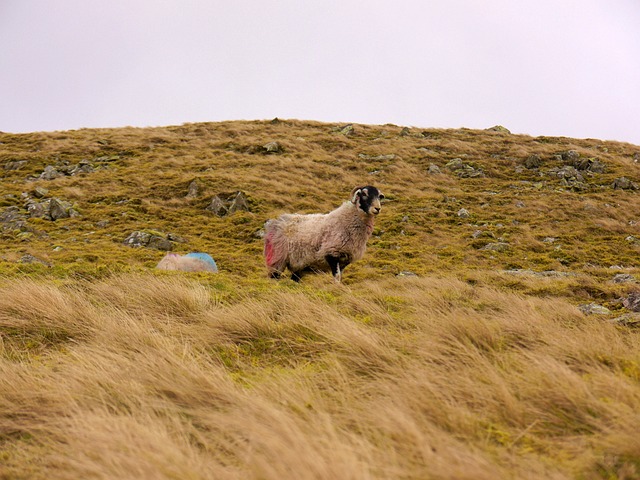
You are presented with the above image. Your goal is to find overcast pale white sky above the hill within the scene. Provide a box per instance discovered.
[0,0,640,145]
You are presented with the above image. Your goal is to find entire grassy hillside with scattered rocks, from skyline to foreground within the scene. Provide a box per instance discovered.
[0,121,640,479]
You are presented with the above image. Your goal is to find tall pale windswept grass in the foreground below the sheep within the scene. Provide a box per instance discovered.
[0,274,640,479]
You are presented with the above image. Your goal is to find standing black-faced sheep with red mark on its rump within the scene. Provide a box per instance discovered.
[264,185,384,283]
